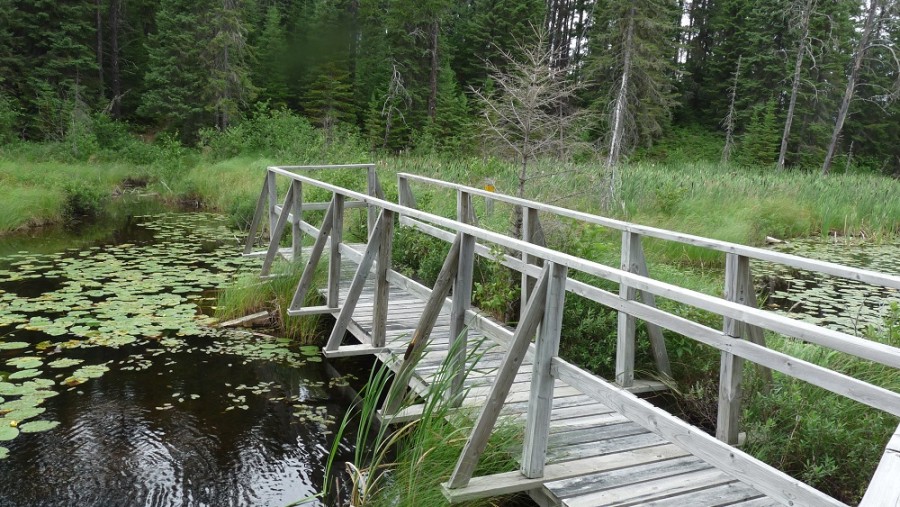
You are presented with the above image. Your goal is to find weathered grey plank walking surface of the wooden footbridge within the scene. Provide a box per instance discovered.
[310,244,781,507]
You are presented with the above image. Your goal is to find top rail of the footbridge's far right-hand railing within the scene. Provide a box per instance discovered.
[397,173,900,289]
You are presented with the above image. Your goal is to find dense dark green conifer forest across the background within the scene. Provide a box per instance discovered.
[0,0,900,174]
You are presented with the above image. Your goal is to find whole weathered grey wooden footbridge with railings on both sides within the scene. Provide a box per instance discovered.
[244,164,900,507]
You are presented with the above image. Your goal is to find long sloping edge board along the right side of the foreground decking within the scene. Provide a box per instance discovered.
[552,358,844,506]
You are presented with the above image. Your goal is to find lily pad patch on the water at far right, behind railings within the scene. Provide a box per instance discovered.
[753,238,900,335]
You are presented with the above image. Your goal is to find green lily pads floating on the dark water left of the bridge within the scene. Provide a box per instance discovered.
[0,214,303,459]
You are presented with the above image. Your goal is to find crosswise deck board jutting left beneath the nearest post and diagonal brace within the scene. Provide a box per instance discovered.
[442,444,688,503]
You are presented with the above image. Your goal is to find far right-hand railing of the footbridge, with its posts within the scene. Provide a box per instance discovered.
[397,173,900,444]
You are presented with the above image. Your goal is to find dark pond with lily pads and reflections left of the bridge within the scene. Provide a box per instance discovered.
[0,207,362,506]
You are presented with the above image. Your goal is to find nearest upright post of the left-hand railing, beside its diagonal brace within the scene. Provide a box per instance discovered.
[522,262,568,479]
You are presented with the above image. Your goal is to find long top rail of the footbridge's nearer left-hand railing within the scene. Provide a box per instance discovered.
[268,166,900,374]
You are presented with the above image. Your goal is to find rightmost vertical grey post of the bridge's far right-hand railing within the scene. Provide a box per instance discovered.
[716,253,756,445]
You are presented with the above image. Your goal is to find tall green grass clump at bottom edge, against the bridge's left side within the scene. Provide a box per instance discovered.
[326,336,522,507]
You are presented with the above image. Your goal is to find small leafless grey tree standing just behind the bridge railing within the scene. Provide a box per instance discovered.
[472,30,585,237]
